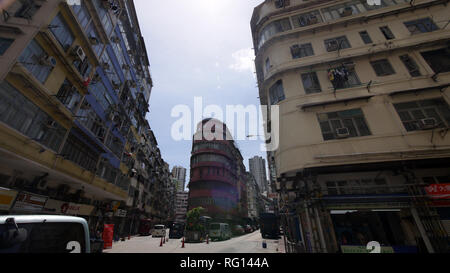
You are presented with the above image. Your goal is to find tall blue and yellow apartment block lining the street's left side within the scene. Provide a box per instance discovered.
[0,0,169,235]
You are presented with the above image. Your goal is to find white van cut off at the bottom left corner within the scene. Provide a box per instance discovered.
[0,215,91,253]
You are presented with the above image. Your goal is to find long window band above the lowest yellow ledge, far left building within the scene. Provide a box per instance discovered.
[0,81,66,151]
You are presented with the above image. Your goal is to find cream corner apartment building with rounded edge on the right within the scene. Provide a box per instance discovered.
[251,0,450,252]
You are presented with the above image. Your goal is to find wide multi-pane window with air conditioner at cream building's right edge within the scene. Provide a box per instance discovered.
[394,98,450,132]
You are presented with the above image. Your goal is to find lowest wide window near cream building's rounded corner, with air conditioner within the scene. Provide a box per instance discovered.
[318,109,371,140]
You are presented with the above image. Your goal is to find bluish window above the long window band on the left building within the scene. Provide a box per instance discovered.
[19,39,53,83]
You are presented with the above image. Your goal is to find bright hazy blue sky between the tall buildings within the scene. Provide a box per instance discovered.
[135,0,266,189]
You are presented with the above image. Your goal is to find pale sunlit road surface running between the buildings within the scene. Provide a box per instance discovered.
[103,230,284,253]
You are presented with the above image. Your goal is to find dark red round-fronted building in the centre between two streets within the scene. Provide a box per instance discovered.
[188,119,248,222]
